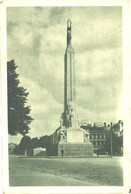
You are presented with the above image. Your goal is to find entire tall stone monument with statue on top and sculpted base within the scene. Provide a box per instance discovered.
[52,19,93,156]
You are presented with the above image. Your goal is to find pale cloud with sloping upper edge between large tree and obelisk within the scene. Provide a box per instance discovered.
[20,77,63,137]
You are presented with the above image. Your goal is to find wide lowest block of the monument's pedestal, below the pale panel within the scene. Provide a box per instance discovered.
[58,142,93,157]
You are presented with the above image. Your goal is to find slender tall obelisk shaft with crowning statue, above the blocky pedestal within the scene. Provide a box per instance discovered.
[63,19,78,128]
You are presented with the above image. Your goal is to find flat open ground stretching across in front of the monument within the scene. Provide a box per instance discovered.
[9,157,123,186]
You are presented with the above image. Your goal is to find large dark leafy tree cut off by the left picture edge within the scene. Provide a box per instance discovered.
[7,60,33,136]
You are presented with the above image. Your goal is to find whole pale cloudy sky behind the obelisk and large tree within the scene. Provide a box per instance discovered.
[7,7,122,144]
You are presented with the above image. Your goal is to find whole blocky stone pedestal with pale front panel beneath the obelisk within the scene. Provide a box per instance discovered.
[51,127,93,157]
